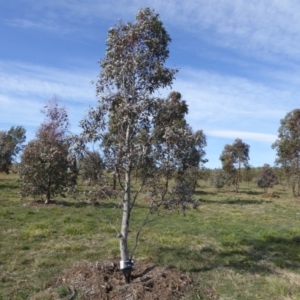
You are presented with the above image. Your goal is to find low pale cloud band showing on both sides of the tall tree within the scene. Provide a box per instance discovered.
[0,61,300,139]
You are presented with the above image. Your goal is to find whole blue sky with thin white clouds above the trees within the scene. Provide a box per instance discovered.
[0,0,300,168]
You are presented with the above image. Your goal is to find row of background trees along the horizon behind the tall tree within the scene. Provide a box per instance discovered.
[0,106,300,195]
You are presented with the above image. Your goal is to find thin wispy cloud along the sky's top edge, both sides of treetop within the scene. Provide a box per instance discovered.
[9,0,300,60]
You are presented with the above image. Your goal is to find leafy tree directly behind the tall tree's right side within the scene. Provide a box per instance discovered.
[153,92,207,200]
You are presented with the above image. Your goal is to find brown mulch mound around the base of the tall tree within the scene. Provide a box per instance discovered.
[56,261,193,300]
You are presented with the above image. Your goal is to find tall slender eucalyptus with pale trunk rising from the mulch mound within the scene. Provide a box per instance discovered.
[81,8,205,282]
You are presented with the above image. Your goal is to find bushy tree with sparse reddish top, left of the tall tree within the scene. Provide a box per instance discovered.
[19,99,77,203]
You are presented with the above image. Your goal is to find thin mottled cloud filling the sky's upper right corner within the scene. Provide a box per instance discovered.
[154,0,300,59]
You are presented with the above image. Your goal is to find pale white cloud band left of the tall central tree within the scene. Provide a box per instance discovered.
[0,61,96,140]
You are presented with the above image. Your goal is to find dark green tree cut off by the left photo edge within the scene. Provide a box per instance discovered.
[0,126,26,173]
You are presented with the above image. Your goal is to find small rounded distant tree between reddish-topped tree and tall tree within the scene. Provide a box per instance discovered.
[79,151,105,185]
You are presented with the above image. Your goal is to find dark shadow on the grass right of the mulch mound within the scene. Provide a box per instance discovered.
[157,236,300,274]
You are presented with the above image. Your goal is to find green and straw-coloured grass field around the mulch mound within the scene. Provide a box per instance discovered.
[0,174,300,300]
